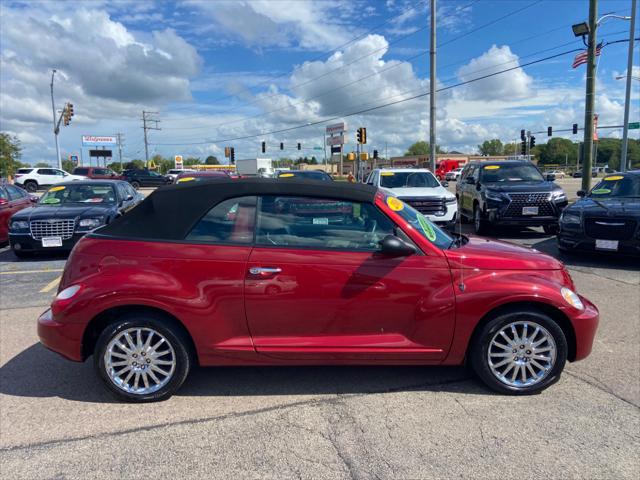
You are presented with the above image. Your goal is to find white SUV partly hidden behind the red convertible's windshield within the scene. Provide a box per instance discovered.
[365,168,458,225]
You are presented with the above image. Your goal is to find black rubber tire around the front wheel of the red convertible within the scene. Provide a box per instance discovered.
[469,310,568,395]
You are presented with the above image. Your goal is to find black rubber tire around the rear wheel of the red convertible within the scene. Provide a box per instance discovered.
[93,313,192,403]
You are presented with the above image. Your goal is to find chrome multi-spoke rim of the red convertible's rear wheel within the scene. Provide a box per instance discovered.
[104,327,176,395]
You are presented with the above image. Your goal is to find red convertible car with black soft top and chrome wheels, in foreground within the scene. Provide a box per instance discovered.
[38,179,598,401]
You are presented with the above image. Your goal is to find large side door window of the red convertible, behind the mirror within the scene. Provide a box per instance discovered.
[256,195,395,251]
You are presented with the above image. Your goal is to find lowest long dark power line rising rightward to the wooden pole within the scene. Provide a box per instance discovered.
[154,48,583,146]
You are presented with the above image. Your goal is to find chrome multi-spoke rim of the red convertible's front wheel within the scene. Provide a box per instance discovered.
[487,321,556,388]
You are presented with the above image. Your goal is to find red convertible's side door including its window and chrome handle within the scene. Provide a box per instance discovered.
[245,196,454,362]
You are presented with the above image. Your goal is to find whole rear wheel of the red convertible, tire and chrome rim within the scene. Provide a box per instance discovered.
[94,314,191,402]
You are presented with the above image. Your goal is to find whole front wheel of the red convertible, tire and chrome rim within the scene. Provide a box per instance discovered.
[470,311,567,395]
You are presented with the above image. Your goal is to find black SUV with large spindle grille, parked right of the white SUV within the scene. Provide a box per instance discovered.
[456,160,567,234]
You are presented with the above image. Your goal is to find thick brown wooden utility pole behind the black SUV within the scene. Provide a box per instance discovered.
[582,0,598,192]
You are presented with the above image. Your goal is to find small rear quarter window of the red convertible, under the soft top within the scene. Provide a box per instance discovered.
[186,197,256,244]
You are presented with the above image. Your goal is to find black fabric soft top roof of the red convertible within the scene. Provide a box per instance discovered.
[91,178,377,240]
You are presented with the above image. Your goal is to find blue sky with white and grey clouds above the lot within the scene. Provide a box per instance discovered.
[0,0,640,163]
